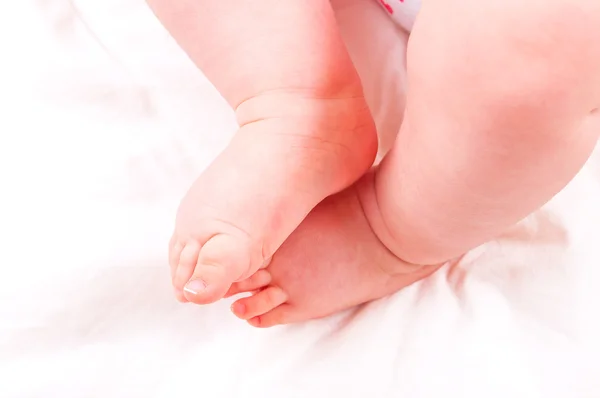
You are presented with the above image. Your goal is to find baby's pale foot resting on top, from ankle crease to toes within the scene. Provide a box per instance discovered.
[169,93,377,304]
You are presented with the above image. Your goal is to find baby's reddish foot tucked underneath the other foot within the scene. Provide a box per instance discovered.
[228,173,440,327]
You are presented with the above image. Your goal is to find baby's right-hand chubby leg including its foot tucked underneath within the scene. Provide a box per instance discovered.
[226,0,600,327]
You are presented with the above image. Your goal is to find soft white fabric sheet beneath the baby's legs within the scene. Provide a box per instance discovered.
[0,0,600,398]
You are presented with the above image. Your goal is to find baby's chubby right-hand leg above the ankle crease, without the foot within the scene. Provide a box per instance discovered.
[366,0,600,264]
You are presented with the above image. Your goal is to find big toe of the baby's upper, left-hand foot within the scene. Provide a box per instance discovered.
[183,235,251,304]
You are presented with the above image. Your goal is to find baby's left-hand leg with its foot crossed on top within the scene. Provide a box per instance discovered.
[148,0,377,304]
